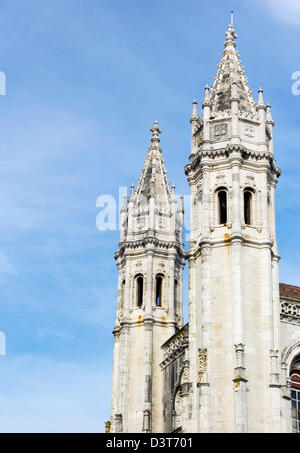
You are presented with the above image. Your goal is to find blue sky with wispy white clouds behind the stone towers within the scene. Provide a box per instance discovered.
[0,0,300,432]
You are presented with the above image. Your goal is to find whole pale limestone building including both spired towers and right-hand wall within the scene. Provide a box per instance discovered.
[110,25,300,433]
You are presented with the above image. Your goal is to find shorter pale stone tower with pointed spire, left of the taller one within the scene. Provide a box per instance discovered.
[111,122,185,432]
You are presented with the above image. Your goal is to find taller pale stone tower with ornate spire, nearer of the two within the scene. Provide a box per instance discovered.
[182,25,285,432]
